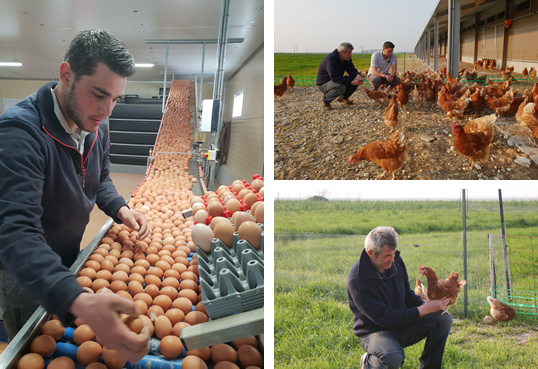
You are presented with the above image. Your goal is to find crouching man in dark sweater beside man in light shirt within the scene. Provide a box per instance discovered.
[316,42,363,110]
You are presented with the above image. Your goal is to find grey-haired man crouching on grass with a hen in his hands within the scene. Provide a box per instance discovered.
[347,227,452,369]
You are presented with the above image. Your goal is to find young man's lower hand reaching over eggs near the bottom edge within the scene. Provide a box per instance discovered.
[69,292,149,363]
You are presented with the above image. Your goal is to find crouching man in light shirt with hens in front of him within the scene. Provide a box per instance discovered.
[368,41,400,90]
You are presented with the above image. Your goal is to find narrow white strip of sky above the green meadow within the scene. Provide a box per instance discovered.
[274,181,538,201]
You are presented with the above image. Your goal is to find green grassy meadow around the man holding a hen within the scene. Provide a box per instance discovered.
[274,201,538,368]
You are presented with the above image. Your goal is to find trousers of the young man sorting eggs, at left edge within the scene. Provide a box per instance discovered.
[0,269,39,341]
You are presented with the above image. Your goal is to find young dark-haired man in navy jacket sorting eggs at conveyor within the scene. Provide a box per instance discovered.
[0,30,149,362]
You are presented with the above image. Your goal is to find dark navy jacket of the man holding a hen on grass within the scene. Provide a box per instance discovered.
[346,250,423,336]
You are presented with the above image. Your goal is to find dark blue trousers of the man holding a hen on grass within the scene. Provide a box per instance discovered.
[359,311,452,369]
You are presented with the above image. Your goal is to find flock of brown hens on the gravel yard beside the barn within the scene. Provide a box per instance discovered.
[274,60,538,179]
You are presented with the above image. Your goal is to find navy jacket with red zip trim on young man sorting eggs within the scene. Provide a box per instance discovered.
[0,82,126,324]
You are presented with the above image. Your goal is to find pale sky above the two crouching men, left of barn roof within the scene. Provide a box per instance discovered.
[275,0,439,53]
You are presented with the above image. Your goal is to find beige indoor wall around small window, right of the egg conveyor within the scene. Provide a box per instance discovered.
[218,49,264,185]
